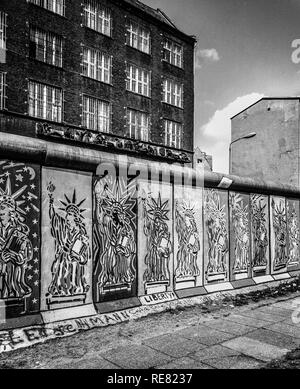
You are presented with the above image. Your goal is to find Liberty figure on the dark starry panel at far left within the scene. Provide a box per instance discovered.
[0,173,33,299]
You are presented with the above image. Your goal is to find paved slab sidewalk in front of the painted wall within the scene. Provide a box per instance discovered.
[0,293,300,369]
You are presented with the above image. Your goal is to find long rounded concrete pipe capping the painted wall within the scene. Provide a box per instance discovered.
[0,133,300,198]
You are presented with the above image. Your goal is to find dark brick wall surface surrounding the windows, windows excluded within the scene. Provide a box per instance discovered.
[0,0,195,155]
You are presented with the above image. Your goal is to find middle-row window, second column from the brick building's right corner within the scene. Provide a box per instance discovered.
[126,65,151,97]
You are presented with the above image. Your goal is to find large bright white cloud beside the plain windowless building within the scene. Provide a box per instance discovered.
[196,93,264,173]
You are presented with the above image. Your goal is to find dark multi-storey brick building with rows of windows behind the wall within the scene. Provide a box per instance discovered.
[0,0,195,162]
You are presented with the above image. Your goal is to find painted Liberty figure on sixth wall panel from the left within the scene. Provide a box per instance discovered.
[205,190,229,282]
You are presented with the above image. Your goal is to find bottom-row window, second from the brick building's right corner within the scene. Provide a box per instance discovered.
[127,109,150,142]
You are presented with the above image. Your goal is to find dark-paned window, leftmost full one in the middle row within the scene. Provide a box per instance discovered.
[29,27,62,67]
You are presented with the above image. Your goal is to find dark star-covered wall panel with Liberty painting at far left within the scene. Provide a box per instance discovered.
[0,161,40,317]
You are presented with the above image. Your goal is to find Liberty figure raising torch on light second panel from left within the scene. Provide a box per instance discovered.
[47,182,91,297]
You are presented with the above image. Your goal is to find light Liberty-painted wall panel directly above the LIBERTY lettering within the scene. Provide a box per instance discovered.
[138,181,174,295]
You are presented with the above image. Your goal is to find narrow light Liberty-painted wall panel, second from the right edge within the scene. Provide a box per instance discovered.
[271,197,288,272]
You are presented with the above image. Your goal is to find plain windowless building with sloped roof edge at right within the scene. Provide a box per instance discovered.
[229,97,300,187]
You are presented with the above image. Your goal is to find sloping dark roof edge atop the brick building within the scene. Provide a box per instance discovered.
[114,0,197,45]
